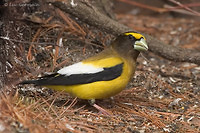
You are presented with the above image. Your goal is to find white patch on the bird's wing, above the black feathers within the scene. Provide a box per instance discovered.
[58,62,104,76]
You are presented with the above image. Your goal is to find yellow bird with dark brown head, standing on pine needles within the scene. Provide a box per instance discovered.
[21,32,148,105]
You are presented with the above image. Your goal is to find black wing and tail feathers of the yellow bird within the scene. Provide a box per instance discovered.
[21,63,123,86]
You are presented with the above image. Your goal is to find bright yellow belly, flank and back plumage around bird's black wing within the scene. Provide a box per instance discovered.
[46,57,135,99]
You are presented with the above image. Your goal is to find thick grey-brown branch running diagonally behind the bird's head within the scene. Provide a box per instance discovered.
[49,0,200,65]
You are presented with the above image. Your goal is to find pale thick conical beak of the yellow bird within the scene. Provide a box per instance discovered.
[134,38,148,51]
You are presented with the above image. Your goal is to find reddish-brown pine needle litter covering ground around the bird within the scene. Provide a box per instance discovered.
[0,0,200,133]
